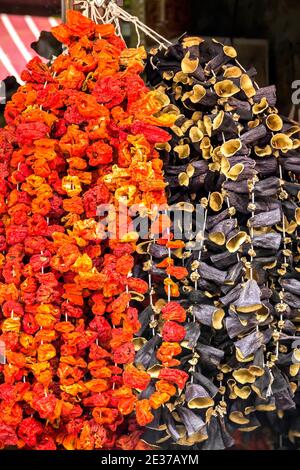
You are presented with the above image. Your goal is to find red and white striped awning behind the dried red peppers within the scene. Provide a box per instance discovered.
[0,14,59,83]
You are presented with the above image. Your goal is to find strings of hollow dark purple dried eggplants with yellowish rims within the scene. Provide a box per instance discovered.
[143,37,300,449]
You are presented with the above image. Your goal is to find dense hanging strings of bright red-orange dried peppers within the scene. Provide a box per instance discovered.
[0,12,187,450]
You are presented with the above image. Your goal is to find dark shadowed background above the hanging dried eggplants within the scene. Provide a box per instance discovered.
[146,0,300,114]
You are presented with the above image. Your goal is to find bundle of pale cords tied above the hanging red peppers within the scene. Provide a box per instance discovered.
[74,0,172,49]
